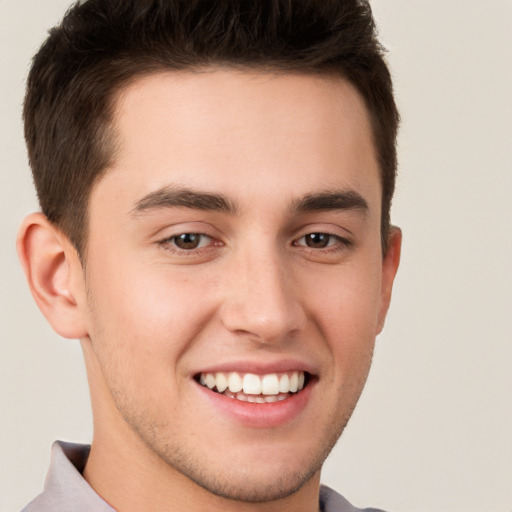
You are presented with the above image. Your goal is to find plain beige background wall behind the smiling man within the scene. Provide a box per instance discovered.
[0,0,512,512]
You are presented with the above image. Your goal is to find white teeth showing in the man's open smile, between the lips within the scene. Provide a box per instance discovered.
[195,371,310,404]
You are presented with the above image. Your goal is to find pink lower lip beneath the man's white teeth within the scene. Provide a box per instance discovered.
[194,380,314,428]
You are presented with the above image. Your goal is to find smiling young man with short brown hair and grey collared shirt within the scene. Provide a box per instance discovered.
[18,0,401,512]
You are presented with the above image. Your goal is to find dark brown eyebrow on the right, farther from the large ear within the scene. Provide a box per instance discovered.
[291,190,369,213]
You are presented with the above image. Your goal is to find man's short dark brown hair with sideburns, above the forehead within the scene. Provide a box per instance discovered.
[24,0,399,256]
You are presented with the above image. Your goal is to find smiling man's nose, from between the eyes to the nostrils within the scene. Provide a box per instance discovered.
[221,246,306,344]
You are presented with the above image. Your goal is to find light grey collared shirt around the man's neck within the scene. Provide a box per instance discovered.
[22,441,383,512]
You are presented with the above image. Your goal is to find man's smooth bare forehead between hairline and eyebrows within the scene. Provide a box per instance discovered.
[95,69,380,216]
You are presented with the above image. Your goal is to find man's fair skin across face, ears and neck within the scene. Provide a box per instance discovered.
[18,69,401,512]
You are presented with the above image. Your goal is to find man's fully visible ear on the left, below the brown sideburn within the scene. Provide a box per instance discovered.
[16,213,87,339]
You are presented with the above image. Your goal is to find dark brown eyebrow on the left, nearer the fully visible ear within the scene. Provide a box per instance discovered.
[131,186,238,215]
